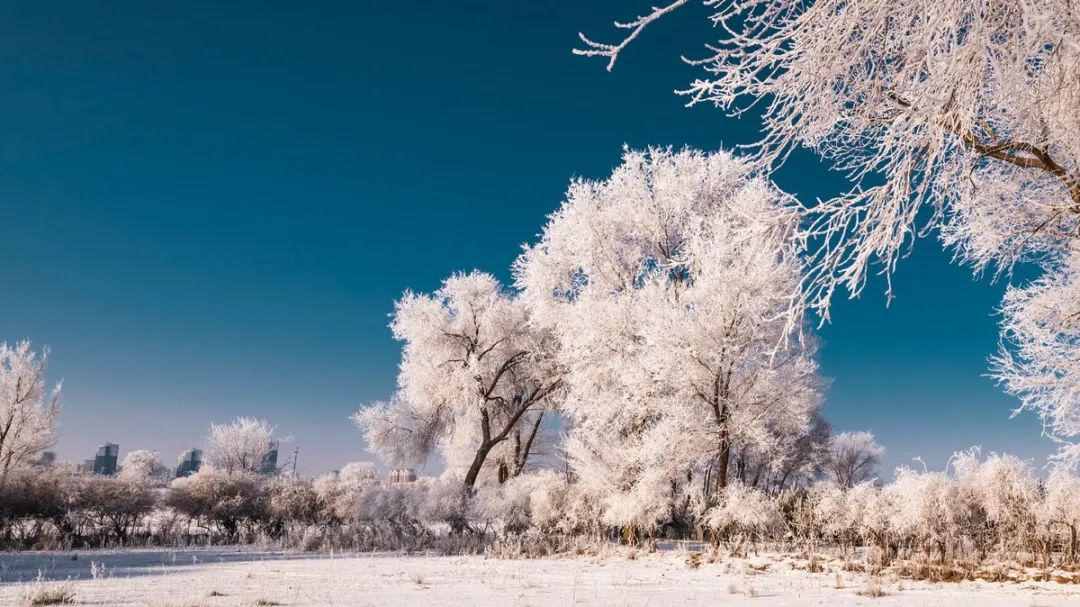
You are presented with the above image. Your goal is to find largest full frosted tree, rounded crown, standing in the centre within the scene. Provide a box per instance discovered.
[514,149,818,527]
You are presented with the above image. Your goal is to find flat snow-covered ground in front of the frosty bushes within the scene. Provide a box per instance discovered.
[0,550,1080,607]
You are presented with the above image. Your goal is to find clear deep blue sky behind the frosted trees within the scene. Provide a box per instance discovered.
[0,0,1051,473]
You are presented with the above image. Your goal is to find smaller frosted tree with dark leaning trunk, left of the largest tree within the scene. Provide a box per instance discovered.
[353,272,562,488]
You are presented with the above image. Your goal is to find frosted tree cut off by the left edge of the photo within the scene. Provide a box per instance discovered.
[0,341,60,486]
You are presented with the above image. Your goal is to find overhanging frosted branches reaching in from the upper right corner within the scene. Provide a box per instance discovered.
[575,0,1080,464]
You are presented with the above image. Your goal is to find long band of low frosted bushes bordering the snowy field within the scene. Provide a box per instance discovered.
[0,450,1080,577]
